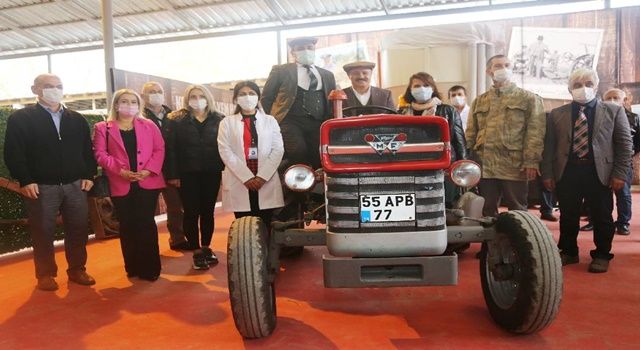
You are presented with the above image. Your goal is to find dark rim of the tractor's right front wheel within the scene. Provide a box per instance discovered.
[484,234,522,310]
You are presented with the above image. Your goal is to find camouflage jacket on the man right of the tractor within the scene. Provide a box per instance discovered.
[466,83,546,181]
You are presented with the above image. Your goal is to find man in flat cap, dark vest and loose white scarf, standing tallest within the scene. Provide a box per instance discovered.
[261,37,336,168]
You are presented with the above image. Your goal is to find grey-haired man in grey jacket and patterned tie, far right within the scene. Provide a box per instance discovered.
[542,69,633,273]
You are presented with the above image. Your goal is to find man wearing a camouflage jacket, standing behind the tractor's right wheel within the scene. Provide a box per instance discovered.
[466,55,546,216]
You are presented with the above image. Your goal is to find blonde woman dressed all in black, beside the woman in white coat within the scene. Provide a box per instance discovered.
[164,85,224,270]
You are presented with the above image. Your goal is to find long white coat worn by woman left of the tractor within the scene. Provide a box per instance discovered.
[218,110,284,212]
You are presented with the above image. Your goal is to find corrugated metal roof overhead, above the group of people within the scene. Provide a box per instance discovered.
[0,0,588,59]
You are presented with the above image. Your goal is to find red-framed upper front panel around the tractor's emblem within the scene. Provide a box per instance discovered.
[329,124,443,164]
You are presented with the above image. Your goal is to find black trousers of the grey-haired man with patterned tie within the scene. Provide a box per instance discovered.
[556,163,614,260]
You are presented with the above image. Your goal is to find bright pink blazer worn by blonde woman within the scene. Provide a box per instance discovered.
[93,118,165,197]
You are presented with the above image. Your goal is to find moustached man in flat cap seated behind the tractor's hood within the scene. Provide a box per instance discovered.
[342,61,395,117]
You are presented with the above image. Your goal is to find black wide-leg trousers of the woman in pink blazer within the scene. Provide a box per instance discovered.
[111,186,160,279]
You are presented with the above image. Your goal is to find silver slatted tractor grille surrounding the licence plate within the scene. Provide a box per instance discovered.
[325,170,445,233]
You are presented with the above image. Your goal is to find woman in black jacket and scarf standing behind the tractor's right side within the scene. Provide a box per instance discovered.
[398,72,467,207]
